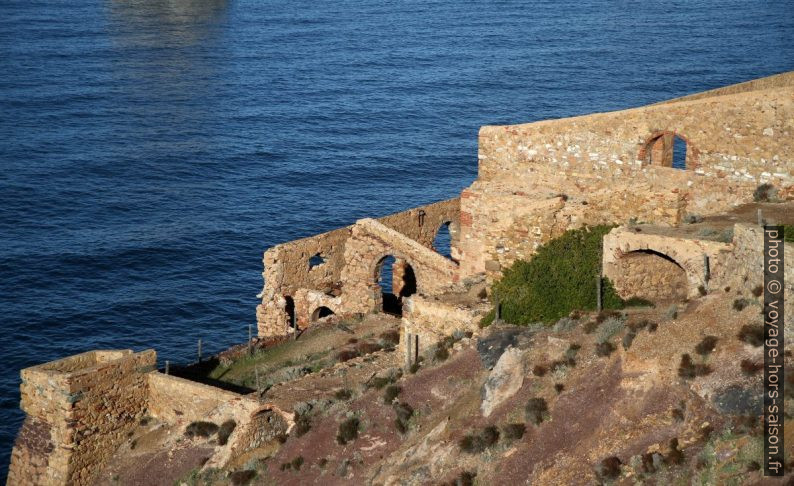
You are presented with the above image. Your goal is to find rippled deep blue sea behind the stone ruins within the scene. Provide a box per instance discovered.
[0,0,794,477]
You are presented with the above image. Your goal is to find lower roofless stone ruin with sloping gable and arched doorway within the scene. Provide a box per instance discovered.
[257,199,460,336]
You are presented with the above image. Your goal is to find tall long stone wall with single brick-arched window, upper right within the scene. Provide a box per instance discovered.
[459,79,794,280]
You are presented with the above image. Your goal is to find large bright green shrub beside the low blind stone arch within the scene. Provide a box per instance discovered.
[483,226,625,325]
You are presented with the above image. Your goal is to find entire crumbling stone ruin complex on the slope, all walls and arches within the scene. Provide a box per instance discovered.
[9,72,794,485]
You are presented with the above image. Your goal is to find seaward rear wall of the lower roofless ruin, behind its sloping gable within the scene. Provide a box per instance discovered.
[257,198,460,336]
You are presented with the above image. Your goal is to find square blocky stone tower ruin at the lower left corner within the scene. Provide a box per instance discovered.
[8,350,157,485]
